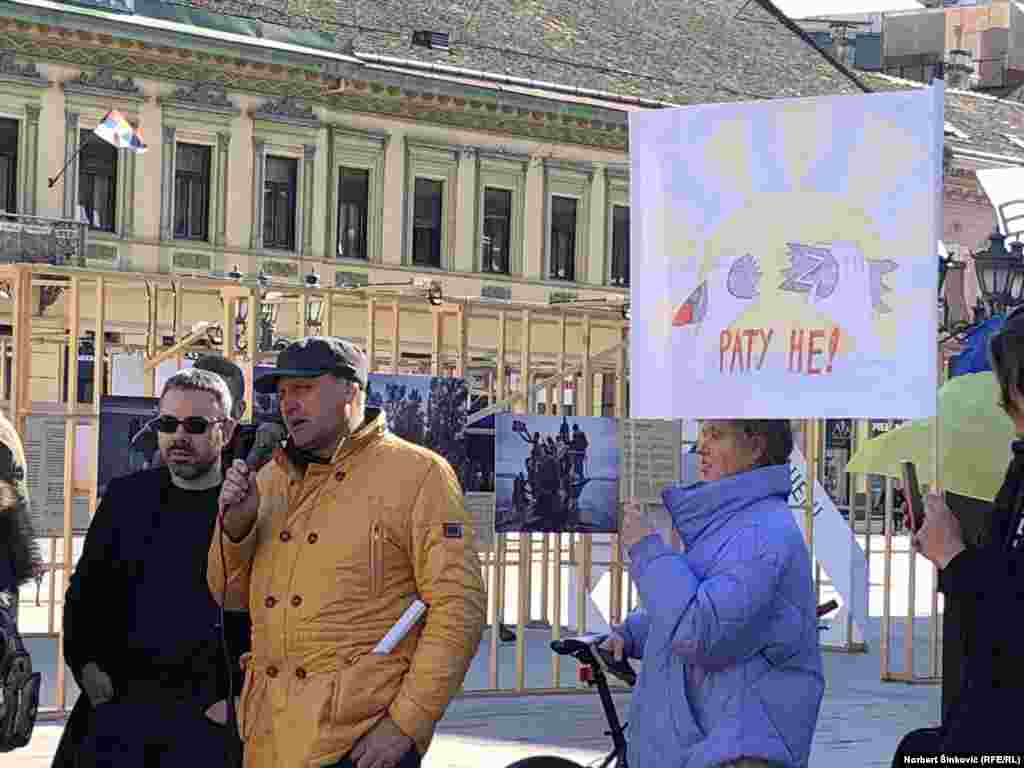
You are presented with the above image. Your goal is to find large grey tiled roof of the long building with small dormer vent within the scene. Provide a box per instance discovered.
[180,0,859,104]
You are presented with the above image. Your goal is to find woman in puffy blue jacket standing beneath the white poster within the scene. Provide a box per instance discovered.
[606,421,824,768]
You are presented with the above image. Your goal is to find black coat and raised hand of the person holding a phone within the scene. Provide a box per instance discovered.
[893,440,1024,768]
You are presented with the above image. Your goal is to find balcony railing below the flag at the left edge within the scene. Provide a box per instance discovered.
[0,212,88,266]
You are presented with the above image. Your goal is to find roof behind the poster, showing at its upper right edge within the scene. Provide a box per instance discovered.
[861,73,1024,164]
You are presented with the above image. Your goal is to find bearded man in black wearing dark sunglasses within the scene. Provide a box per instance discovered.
[53,370,250,768]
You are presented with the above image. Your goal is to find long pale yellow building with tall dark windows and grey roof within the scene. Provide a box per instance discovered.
[0,0,880,409]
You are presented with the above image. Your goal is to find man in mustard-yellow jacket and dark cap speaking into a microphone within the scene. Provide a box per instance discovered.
[208,337,486,768]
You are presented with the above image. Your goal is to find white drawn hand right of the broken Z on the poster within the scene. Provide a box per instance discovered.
[808,240,879,355]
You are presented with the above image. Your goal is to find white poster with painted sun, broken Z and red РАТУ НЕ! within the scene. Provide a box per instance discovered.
[630,81,943,419]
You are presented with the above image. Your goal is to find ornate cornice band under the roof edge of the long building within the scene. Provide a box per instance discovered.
[0,18,628,153]
